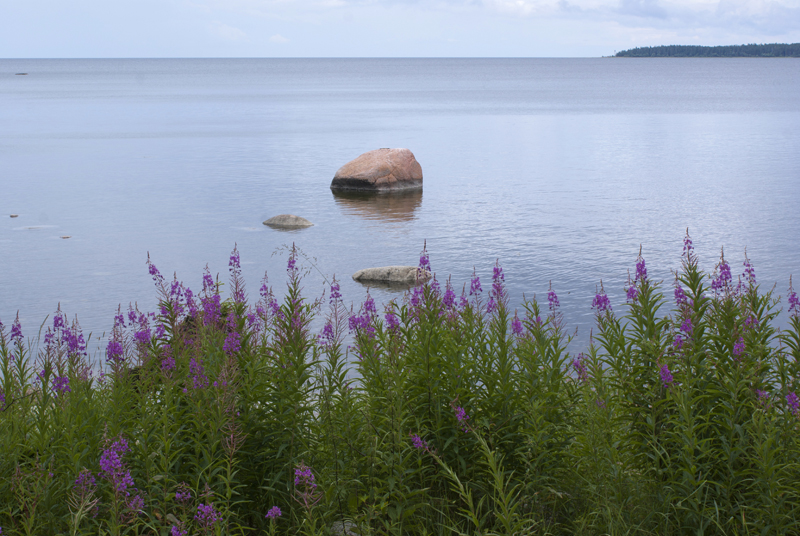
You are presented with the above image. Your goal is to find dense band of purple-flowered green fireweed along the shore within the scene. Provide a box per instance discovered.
[0,239,800,536]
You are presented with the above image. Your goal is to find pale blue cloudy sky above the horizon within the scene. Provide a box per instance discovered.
[0,0,800,58]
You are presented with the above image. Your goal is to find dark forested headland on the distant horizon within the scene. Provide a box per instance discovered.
[614,43,800,58]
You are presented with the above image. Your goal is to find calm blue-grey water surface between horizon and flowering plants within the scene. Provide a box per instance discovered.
[0,59,800,352]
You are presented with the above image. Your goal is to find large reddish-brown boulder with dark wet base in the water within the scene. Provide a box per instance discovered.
[331,149,422,192]
